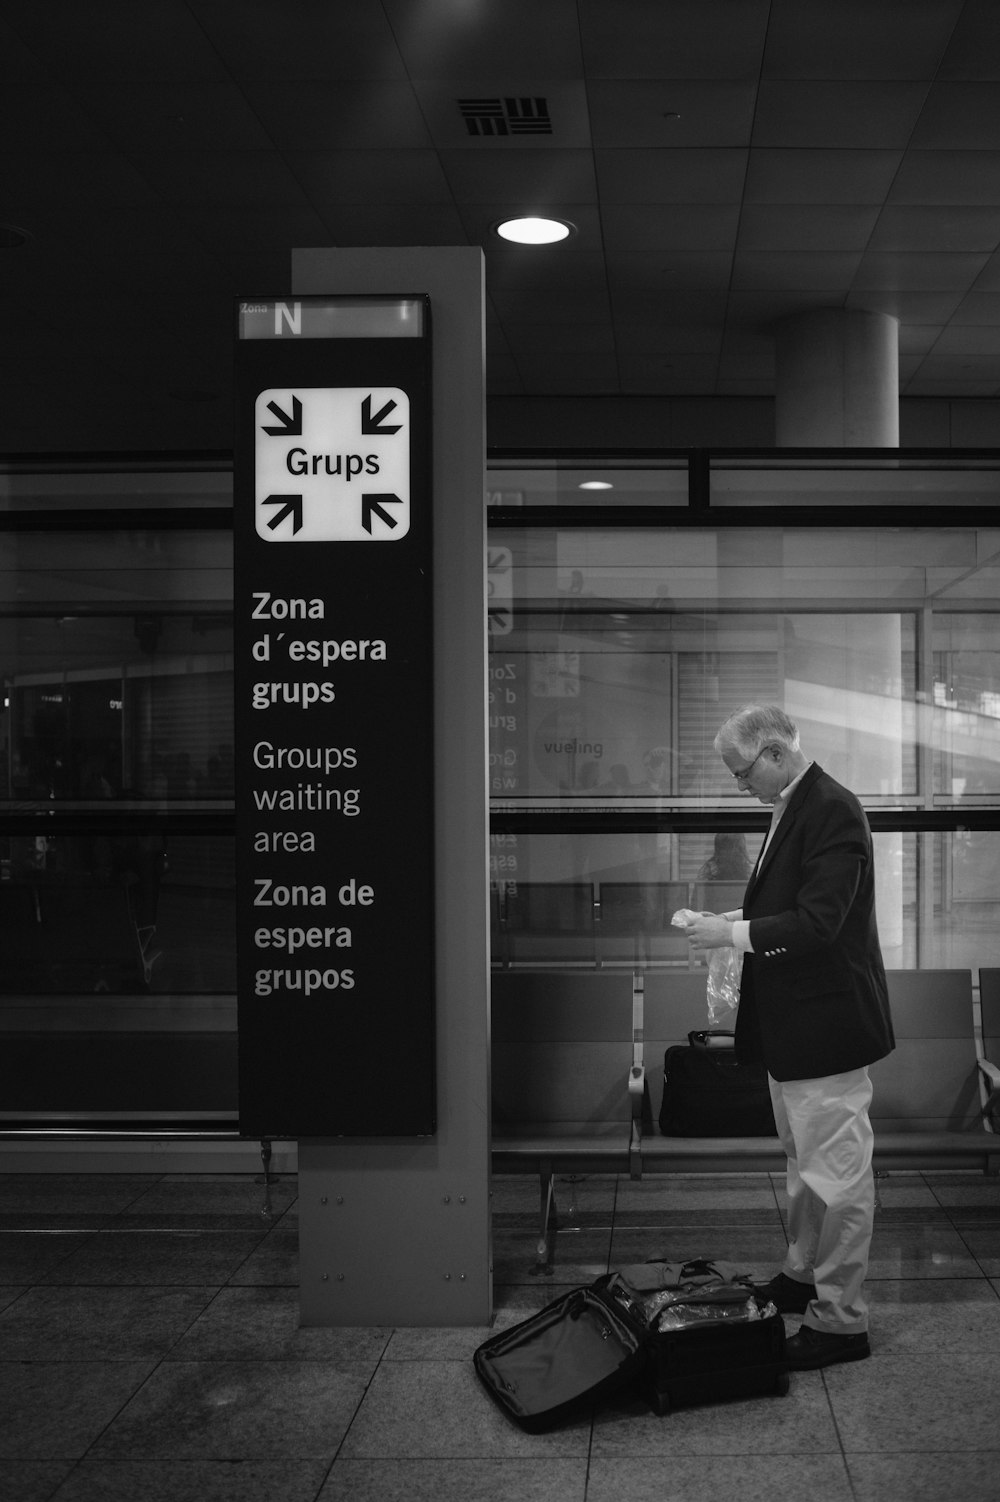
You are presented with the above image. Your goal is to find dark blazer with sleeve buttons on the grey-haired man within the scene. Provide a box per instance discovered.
[736,763,895,1080]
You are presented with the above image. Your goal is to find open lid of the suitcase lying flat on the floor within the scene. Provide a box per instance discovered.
[473,1275,647,1433]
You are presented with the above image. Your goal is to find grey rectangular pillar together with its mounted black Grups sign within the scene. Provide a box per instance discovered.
[236,246,492,1325]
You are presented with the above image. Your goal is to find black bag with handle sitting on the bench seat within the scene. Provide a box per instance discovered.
[659,1029,778,1137]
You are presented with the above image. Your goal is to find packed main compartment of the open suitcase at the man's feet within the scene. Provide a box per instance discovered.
[643,1281,788,1415]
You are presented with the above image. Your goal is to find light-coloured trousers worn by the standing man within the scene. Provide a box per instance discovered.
[770,1069,875,1335]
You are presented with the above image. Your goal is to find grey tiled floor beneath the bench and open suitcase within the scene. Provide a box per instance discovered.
[0,1173,1000,1502]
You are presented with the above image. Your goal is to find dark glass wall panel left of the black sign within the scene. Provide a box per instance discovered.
[0,516,236,1125]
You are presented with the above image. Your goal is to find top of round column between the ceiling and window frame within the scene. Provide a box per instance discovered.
[775,308,899,449]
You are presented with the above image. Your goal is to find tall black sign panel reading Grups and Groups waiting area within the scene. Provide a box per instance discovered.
[234,297,435,1137]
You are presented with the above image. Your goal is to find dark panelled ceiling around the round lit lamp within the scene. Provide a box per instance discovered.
[0,0,1000,452]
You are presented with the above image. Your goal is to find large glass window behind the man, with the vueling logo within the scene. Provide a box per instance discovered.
[489,518,1000,967]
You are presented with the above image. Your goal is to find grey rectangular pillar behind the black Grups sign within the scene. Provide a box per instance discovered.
[293,246,492,1326]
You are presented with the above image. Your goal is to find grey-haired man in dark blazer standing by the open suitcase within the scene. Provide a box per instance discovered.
[688,704,893,1370]
